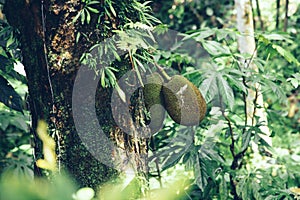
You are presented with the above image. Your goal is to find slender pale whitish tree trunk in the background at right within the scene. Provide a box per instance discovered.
[235,0,272,145]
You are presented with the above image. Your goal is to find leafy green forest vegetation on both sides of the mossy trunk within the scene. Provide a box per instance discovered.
[0,0,300,200]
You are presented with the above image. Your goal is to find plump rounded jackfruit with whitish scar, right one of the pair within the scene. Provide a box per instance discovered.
[162,75,206,126]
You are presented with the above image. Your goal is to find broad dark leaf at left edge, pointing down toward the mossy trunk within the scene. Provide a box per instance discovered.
[0,75,23,113]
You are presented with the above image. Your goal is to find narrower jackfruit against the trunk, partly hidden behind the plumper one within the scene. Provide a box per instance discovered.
[144,72,166,133]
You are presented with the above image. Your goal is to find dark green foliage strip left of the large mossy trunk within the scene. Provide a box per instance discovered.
[0,13,33,178]
